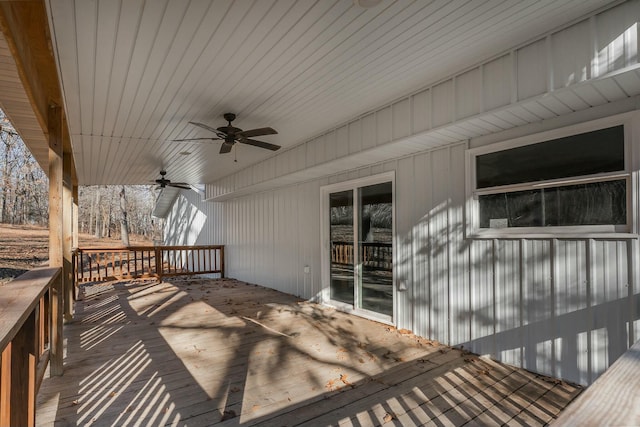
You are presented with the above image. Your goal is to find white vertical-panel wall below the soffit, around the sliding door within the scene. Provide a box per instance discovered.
[198,141,640,384]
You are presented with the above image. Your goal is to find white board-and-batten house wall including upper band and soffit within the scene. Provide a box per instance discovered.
[161,1,640,384]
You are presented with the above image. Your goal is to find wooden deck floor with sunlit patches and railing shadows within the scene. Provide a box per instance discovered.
[37,279,581,426]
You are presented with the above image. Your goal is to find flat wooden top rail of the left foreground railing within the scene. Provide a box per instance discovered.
[0,267,61,349]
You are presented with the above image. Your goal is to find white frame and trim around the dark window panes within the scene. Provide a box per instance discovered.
[465,114,637,238]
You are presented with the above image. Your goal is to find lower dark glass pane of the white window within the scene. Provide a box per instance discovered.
[479,179,627,228]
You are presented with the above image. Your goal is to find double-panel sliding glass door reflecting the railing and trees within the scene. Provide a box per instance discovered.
[329,182,393,318]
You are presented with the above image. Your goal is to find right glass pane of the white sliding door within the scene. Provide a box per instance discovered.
[358,182,393,316]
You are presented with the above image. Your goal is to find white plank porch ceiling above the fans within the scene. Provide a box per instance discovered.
[47,0,611,185]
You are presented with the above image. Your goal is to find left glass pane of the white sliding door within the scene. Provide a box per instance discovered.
[329,190,354,304]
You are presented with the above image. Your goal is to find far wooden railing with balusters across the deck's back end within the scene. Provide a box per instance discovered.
[73,245,224,283]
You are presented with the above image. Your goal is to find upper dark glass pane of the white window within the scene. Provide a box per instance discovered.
[476,126,625,188]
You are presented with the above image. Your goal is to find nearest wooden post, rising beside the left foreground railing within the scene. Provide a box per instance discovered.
[48,104,64,376]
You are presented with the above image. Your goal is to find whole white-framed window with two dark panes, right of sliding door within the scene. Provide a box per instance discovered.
[467,119,631,237]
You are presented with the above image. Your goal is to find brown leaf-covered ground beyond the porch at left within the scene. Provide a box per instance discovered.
[0,224,151,285]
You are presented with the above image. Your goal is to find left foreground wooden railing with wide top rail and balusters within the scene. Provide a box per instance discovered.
[0,268,62,426]
